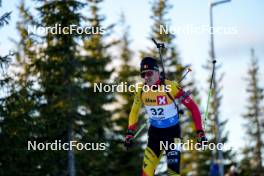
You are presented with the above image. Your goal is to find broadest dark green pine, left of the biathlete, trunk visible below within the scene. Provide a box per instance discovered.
[34,1,84,176]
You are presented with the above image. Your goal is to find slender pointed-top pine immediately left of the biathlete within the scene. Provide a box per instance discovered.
[105,13,143,176]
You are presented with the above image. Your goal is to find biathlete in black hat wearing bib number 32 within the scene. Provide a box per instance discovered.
[125,57,207,176]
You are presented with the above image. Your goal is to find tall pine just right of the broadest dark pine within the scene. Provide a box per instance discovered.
[77,0,116,176]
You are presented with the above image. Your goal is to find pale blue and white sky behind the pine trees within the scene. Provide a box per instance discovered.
[0,0,264,160]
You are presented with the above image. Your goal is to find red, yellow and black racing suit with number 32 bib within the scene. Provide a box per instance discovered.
[128,80,203,176]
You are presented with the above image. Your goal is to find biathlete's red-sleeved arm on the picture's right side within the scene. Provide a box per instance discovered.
[175,89,203,131]
